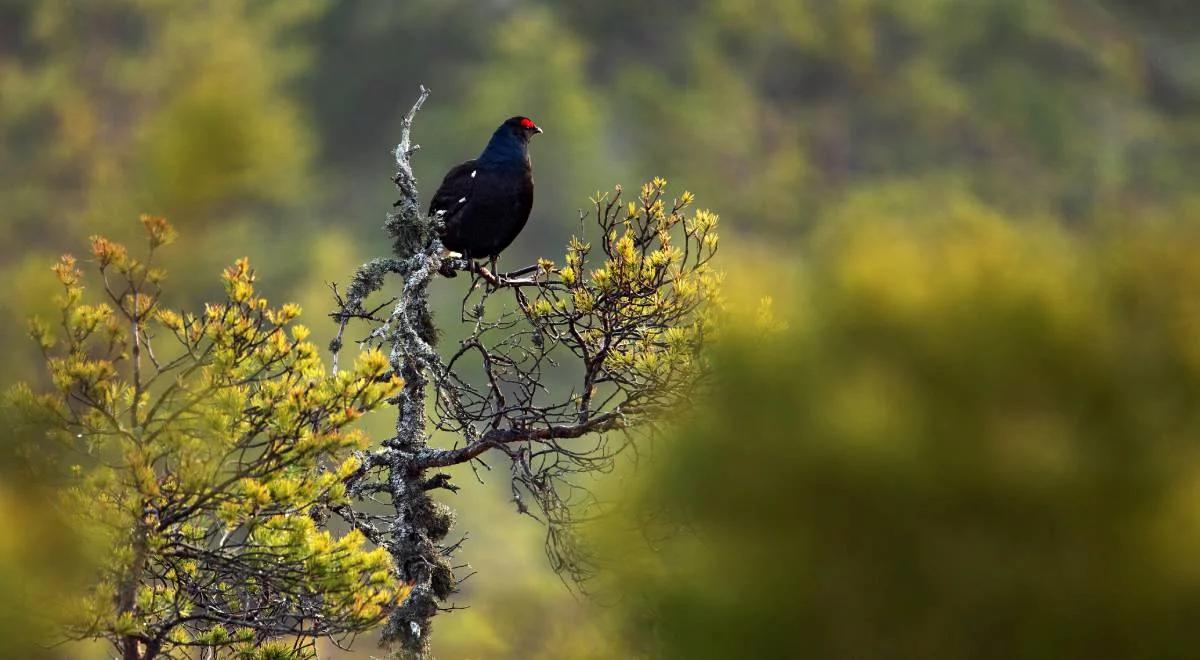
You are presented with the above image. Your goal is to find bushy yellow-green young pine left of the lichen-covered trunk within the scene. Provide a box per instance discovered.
[7,216,403,656]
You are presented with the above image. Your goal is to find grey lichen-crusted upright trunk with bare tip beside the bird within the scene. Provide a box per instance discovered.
[330,88,455,658]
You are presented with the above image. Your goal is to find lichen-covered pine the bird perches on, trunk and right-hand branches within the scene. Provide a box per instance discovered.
[331,89,720,656]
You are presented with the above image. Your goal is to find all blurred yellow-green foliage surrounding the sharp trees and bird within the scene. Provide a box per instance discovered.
[7,0,1200,658]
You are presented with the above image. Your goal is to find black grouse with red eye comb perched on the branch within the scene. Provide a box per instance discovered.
[428,116,542,277]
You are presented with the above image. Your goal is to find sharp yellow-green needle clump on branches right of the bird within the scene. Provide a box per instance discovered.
[522,178,722,403]
